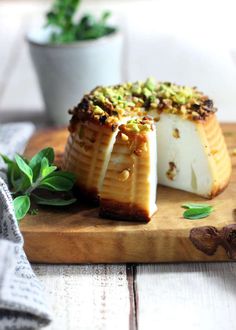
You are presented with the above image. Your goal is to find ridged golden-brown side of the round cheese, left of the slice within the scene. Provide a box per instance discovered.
[63,121,116,199]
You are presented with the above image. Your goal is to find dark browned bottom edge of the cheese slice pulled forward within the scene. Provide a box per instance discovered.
[99,199,151,222]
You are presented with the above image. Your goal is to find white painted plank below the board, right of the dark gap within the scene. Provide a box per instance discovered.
[136,263,236,330]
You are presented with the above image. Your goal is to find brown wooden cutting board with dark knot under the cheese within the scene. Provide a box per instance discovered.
[20,124,236,263]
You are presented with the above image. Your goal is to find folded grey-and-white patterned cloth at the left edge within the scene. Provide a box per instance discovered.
[0,123,51,330]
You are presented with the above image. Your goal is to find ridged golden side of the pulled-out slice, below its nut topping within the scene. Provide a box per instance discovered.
[101,132,157,218]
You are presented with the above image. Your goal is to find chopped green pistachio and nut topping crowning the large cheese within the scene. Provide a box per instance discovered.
[69,78,216,130]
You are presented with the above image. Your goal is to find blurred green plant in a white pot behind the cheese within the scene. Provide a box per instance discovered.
[27,0,123,125]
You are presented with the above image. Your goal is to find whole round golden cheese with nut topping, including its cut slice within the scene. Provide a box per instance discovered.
[63,79,231,221]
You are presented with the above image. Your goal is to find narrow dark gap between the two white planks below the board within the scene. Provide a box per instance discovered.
[126,264,138,330]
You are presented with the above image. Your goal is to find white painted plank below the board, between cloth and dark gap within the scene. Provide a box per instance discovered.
[33,265,130,330]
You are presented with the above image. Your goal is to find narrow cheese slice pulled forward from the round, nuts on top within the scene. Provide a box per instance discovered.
[100,117,157,221]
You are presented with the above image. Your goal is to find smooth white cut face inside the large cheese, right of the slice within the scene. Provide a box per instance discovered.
[157,113,213,196]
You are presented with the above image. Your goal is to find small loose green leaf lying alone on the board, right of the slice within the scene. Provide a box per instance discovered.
[182,203,214,220]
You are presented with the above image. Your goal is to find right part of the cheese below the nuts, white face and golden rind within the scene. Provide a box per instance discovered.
[157,113,231,198]
